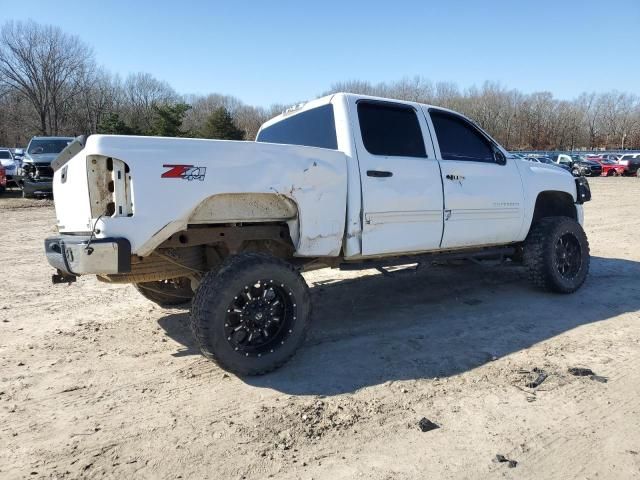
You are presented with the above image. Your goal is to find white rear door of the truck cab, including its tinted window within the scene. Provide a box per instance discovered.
[349,99,443,255]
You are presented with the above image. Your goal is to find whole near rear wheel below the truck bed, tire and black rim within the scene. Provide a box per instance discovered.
[191,253,311,375]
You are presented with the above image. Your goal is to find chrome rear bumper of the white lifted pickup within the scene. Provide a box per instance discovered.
[44,235,131,276]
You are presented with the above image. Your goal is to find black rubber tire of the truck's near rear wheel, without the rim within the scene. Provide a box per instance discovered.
[191,253,311,375]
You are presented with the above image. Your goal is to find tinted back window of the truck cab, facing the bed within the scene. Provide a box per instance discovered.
[256,104,338,150]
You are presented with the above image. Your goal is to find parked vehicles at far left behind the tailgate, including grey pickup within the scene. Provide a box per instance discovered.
[0,137,73,198]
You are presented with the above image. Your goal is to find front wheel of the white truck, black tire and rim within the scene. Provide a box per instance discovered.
[523,217,590,293]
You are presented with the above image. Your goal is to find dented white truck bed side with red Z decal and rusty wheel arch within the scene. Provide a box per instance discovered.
[54,135,347,257]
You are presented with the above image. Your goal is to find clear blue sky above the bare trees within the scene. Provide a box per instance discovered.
[0,0,640,106]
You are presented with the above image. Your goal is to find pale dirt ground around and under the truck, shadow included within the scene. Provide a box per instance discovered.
[0,178,640,480]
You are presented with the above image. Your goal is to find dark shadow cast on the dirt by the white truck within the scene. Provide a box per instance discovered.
[159,257,640,395]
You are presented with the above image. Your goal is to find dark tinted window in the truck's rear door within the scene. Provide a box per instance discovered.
[358,102,427,157]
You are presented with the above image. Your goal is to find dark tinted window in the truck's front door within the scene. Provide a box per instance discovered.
[429,110,495,163]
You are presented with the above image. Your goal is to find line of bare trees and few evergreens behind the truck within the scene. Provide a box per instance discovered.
[0,21,640,150]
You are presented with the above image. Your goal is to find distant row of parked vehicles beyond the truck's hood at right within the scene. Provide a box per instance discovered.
[512,152,640,177]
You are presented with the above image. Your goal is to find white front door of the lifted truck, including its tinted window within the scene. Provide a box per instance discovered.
[424,107,524,248]
